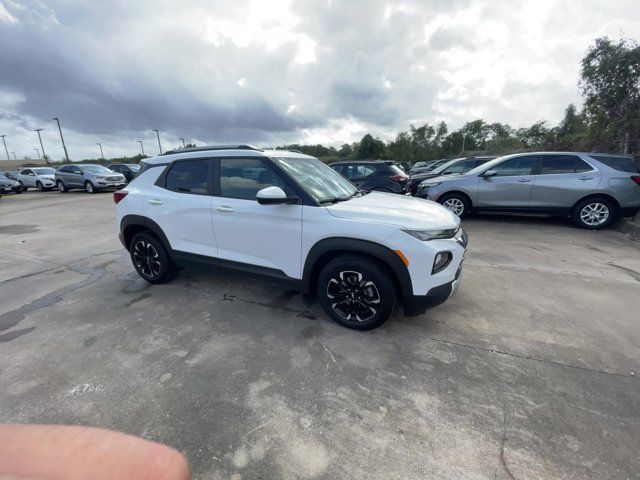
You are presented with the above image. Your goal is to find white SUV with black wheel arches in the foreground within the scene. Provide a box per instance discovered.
[114,145,467,330]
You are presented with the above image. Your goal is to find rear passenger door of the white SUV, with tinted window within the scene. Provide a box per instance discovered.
[143,158,218,258]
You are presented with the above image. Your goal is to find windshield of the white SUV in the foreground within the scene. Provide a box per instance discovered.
[273,158,358,203]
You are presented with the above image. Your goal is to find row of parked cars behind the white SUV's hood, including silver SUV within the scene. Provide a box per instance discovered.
[331,152,640,230]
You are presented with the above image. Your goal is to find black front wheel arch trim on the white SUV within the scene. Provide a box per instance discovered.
[302,237,413,296]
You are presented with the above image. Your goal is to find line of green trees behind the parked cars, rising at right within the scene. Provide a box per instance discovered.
[277,37,640,162]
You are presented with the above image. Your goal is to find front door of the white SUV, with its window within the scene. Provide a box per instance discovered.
[212,158,302,278]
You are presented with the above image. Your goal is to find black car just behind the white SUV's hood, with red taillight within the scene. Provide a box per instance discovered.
[329,160,409,194]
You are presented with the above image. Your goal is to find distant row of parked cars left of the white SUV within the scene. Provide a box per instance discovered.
[0,163,140,194]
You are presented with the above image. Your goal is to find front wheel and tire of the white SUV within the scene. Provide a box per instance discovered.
[317,255,396,330]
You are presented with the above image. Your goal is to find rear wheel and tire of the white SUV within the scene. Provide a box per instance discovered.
[129,232,178,284]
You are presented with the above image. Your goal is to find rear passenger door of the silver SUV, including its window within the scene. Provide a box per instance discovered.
[531,154,601,208]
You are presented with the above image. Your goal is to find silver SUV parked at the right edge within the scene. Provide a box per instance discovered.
[421,152,640,230]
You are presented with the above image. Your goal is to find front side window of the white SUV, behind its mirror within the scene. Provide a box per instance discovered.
[220,158,290,200]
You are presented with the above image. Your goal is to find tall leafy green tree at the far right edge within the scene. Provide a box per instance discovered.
[579,37,640,152]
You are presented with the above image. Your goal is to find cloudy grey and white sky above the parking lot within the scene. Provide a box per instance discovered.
[0,0,640,160]
